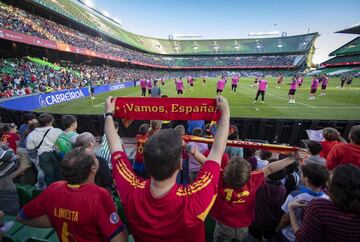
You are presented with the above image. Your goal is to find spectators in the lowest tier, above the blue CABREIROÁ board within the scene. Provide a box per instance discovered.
[0,58,292,98]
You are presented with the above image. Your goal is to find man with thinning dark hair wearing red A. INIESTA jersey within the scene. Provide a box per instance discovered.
[17,147,127,242]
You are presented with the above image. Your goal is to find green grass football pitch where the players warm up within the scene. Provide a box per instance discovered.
[36,77,360,120]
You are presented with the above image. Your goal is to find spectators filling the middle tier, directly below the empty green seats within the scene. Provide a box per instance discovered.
[0,2,301,67]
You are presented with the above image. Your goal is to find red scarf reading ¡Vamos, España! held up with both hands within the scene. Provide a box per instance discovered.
[115,97,221,120]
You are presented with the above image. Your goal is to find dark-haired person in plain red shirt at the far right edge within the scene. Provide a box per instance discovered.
[326,125,360,170]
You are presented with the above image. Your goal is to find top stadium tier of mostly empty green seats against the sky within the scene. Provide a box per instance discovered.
[31,0,318,55]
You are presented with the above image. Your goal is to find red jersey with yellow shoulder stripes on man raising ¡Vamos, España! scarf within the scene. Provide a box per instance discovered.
[112,152,220,242]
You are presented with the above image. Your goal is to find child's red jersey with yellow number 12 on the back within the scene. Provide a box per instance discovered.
[210,170,264,228]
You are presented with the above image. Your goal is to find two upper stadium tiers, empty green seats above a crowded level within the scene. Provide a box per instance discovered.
[0,0,318,72]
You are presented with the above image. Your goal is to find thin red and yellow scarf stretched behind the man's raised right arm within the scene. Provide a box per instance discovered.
[183,135,300,154]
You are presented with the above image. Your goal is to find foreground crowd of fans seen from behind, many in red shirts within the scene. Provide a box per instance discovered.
[0,97,360,241]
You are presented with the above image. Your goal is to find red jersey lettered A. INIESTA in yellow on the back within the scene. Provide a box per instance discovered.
[20,181,124,242]
